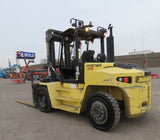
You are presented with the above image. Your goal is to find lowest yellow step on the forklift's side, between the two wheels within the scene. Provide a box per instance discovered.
[54,104,79,113]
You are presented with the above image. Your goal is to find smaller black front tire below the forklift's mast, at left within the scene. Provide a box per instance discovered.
[36,87,53,113]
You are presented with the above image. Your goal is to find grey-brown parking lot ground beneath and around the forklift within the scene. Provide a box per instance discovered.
[0,79,160,140]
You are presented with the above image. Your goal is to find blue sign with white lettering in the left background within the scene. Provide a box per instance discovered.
[16,51,36,59]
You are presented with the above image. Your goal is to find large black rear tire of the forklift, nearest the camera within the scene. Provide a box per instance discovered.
[86,92,120,131]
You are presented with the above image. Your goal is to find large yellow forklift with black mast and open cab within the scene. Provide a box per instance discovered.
[32,18,151,131]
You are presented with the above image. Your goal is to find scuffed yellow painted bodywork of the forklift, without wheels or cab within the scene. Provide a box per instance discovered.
[39,63,151,118]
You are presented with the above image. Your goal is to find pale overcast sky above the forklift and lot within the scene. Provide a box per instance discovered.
[0,0,160,67]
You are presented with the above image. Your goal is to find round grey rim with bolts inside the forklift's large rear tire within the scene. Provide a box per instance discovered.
[90,100,108,124]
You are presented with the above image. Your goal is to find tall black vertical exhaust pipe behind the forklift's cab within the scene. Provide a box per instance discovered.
[107,24,114,62]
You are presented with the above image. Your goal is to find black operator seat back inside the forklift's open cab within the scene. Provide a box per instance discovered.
[81,50,95,63]
